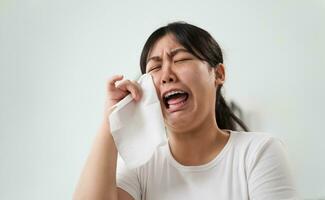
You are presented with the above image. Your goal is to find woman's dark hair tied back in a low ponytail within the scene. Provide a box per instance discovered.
[140,22,248,131]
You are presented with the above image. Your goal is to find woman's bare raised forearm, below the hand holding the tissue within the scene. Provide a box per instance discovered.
[73,118,118,200]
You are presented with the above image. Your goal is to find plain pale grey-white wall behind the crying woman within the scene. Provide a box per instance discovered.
[0,0,325,200]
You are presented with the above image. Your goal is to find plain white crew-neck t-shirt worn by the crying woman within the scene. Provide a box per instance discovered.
[117,131,300,200]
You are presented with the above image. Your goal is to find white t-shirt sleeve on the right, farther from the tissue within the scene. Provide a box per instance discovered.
[247,137,300,200]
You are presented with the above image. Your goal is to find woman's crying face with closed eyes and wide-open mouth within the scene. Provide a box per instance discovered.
[146,34,224,131]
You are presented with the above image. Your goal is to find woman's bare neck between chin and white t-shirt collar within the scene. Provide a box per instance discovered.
[169,115,229,166]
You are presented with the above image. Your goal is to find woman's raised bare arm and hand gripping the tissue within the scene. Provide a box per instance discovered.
[73,76,140,200]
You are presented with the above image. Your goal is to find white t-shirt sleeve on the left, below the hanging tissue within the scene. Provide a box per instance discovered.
[116,156,141,200]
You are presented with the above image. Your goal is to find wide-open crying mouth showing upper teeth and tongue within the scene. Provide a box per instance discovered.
[163,90,188,109]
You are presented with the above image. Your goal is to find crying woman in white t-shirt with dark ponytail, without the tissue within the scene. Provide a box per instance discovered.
[74,22,298,200]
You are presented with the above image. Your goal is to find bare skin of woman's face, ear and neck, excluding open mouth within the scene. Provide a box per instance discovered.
[143,34,229,165]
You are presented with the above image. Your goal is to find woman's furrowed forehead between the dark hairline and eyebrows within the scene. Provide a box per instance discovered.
[147,34,185,58]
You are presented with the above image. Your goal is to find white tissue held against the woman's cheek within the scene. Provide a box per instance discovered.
[109,74,167,169]
